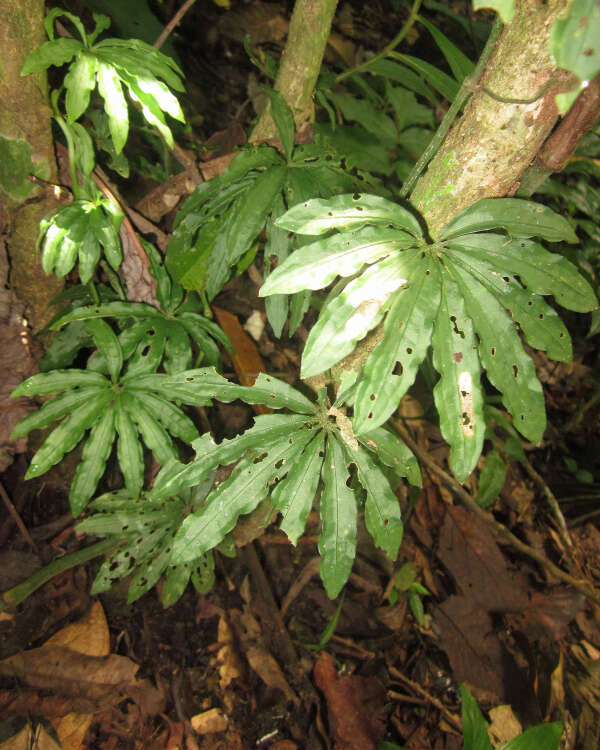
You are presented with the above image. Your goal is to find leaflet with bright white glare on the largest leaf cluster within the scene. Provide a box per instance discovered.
[301,251,410,378]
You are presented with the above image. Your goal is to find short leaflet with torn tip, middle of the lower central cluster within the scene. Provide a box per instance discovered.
[271,430,325,545]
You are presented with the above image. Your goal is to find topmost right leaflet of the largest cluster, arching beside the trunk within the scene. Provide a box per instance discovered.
[440,198,579,243]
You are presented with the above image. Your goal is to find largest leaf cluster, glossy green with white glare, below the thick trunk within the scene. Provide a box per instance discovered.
[260,194,597,481]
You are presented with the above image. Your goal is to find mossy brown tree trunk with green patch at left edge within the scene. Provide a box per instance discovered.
[0,0,62,330]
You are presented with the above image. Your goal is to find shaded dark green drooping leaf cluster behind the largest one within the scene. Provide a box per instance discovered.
[167,91,384,335]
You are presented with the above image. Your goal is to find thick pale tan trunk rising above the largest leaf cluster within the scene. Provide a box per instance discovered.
[411,0,572,239]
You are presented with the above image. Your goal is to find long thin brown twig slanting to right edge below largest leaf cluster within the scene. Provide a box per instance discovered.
[393,420,600,604]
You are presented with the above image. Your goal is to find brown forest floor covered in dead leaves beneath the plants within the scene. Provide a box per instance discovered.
[0,3,600,750]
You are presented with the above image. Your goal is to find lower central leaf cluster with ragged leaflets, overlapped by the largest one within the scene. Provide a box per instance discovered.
[150,374,420,597]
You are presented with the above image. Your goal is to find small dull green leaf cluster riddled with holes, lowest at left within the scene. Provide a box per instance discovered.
[77,484,214,607]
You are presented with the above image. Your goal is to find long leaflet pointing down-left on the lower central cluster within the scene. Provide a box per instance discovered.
[171,429,314,563]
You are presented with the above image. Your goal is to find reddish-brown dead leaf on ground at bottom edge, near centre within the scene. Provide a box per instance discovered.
[313,652,386,750]
